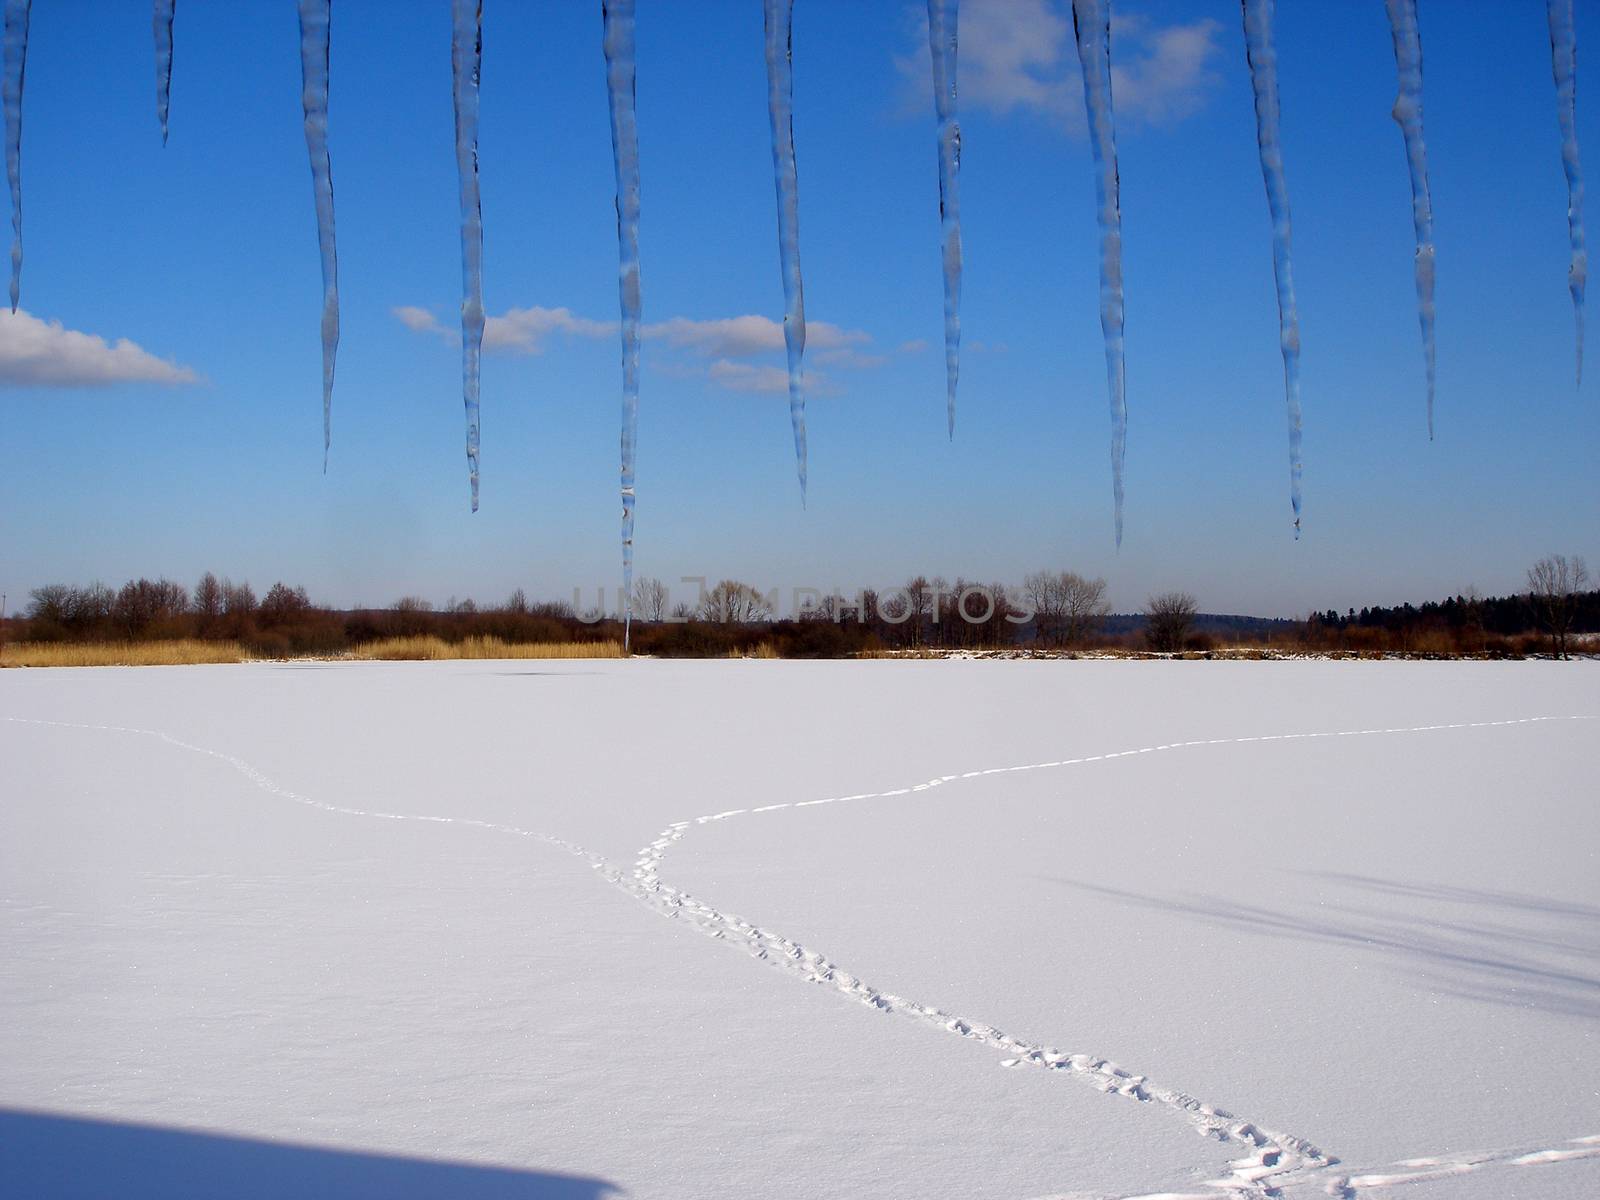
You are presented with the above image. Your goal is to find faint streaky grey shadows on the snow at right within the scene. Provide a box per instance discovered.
[1050,872,1600,1021]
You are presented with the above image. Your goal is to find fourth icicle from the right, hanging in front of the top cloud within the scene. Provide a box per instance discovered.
[1072,0,1128,547]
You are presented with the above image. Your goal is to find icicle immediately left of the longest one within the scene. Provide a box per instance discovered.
[450,0,483,512]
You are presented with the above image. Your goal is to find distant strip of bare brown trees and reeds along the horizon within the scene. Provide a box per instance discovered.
[0,557,1600,658]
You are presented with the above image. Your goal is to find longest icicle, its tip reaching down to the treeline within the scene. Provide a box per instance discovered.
[600,0,640,650]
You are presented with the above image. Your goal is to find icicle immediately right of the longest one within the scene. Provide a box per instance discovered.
[766,0,806,504]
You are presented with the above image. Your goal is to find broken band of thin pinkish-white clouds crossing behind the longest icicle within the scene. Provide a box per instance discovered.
[392,304,888,395]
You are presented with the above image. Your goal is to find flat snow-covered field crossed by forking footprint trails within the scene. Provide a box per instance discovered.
[0,661,1600,1200]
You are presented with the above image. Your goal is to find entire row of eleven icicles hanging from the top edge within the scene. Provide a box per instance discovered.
[0,0,1587,598]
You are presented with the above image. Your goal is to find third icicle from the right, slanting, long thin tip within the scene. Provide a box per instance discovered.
[1240,0,1301,538]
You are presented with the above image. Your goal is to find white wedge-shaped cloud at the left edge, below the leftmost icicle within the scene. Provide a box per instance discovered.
[0,307,200,387]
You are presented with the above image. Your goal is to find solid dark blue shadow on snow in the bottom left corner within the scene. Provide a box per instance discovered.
[0,1109,619,1200]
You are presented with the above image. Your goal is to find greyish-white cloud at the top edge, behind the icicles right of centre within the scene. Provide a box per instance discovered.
[896,0,1222,131]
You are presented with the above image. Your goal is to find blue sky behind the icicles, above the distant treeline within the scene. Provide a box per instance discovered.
[0,0,1600,614]
